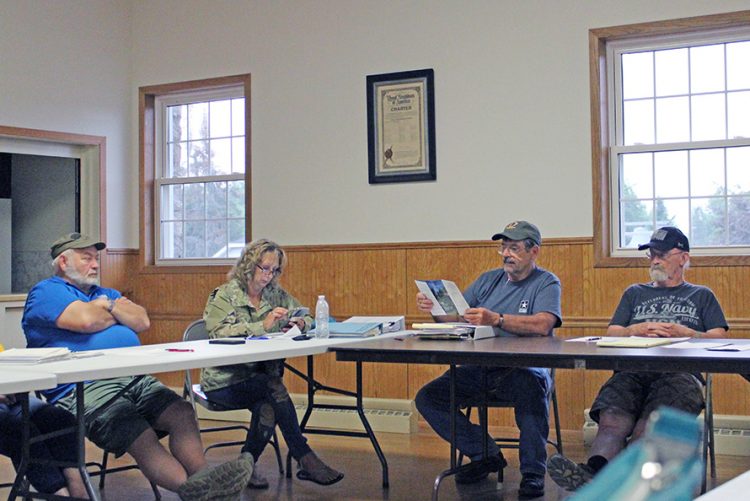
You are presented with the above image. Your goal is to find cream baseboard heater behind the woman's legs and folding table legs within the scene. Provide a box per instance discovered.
[181,386,417,433]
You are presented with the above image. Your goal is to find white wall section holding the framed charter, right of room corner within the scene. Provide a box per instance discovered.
[133,0,748,244]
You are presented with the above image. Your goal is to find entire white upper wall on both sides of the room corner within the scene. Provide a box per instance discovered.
[0,0,749,247]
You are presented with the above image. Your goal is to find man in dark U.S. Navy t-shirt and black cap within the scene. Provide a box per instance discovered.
[547,226,729,491]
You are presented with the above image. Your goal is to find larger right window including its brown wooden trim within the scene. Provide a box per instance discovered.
[591,13,750,264]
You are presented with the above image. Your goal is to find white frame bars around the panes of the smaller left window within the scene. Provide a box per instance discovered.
[153,84,249,266]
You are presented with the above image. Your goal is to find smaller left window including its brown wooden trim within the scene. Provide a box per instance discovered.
[141,75,254,265]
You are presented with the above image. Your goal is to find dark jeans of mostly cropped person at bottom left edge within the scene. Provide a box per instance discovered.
[0,397,78,494]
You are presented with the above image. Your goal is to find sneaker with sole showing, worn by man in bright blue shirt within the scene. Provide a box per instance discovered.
[177,454,254,501]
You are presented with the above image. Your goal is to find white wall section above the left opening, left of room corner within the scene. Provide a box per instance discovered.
[0,0,132,248]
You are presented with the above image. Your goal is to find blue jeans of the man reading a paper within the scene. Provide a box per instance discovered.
[415,365,553,475]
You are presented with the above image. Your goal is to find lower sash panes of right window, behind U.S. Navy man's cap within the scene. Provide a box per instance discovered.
[618,146,750,248]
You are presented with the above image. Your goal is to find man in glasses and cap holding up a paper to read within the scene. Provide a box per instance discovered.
[416,221,562,499]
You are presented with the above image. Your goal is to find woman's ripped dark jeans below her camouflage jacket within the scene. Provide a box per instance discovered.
[206,373,311,461]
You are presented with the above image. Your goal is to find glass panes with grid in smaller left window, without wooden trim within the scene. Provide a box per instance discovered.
[155,88,245,261]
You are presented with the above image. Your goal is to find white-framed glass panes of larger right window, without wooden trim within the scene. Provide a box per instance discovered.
[610,31,750,253]
